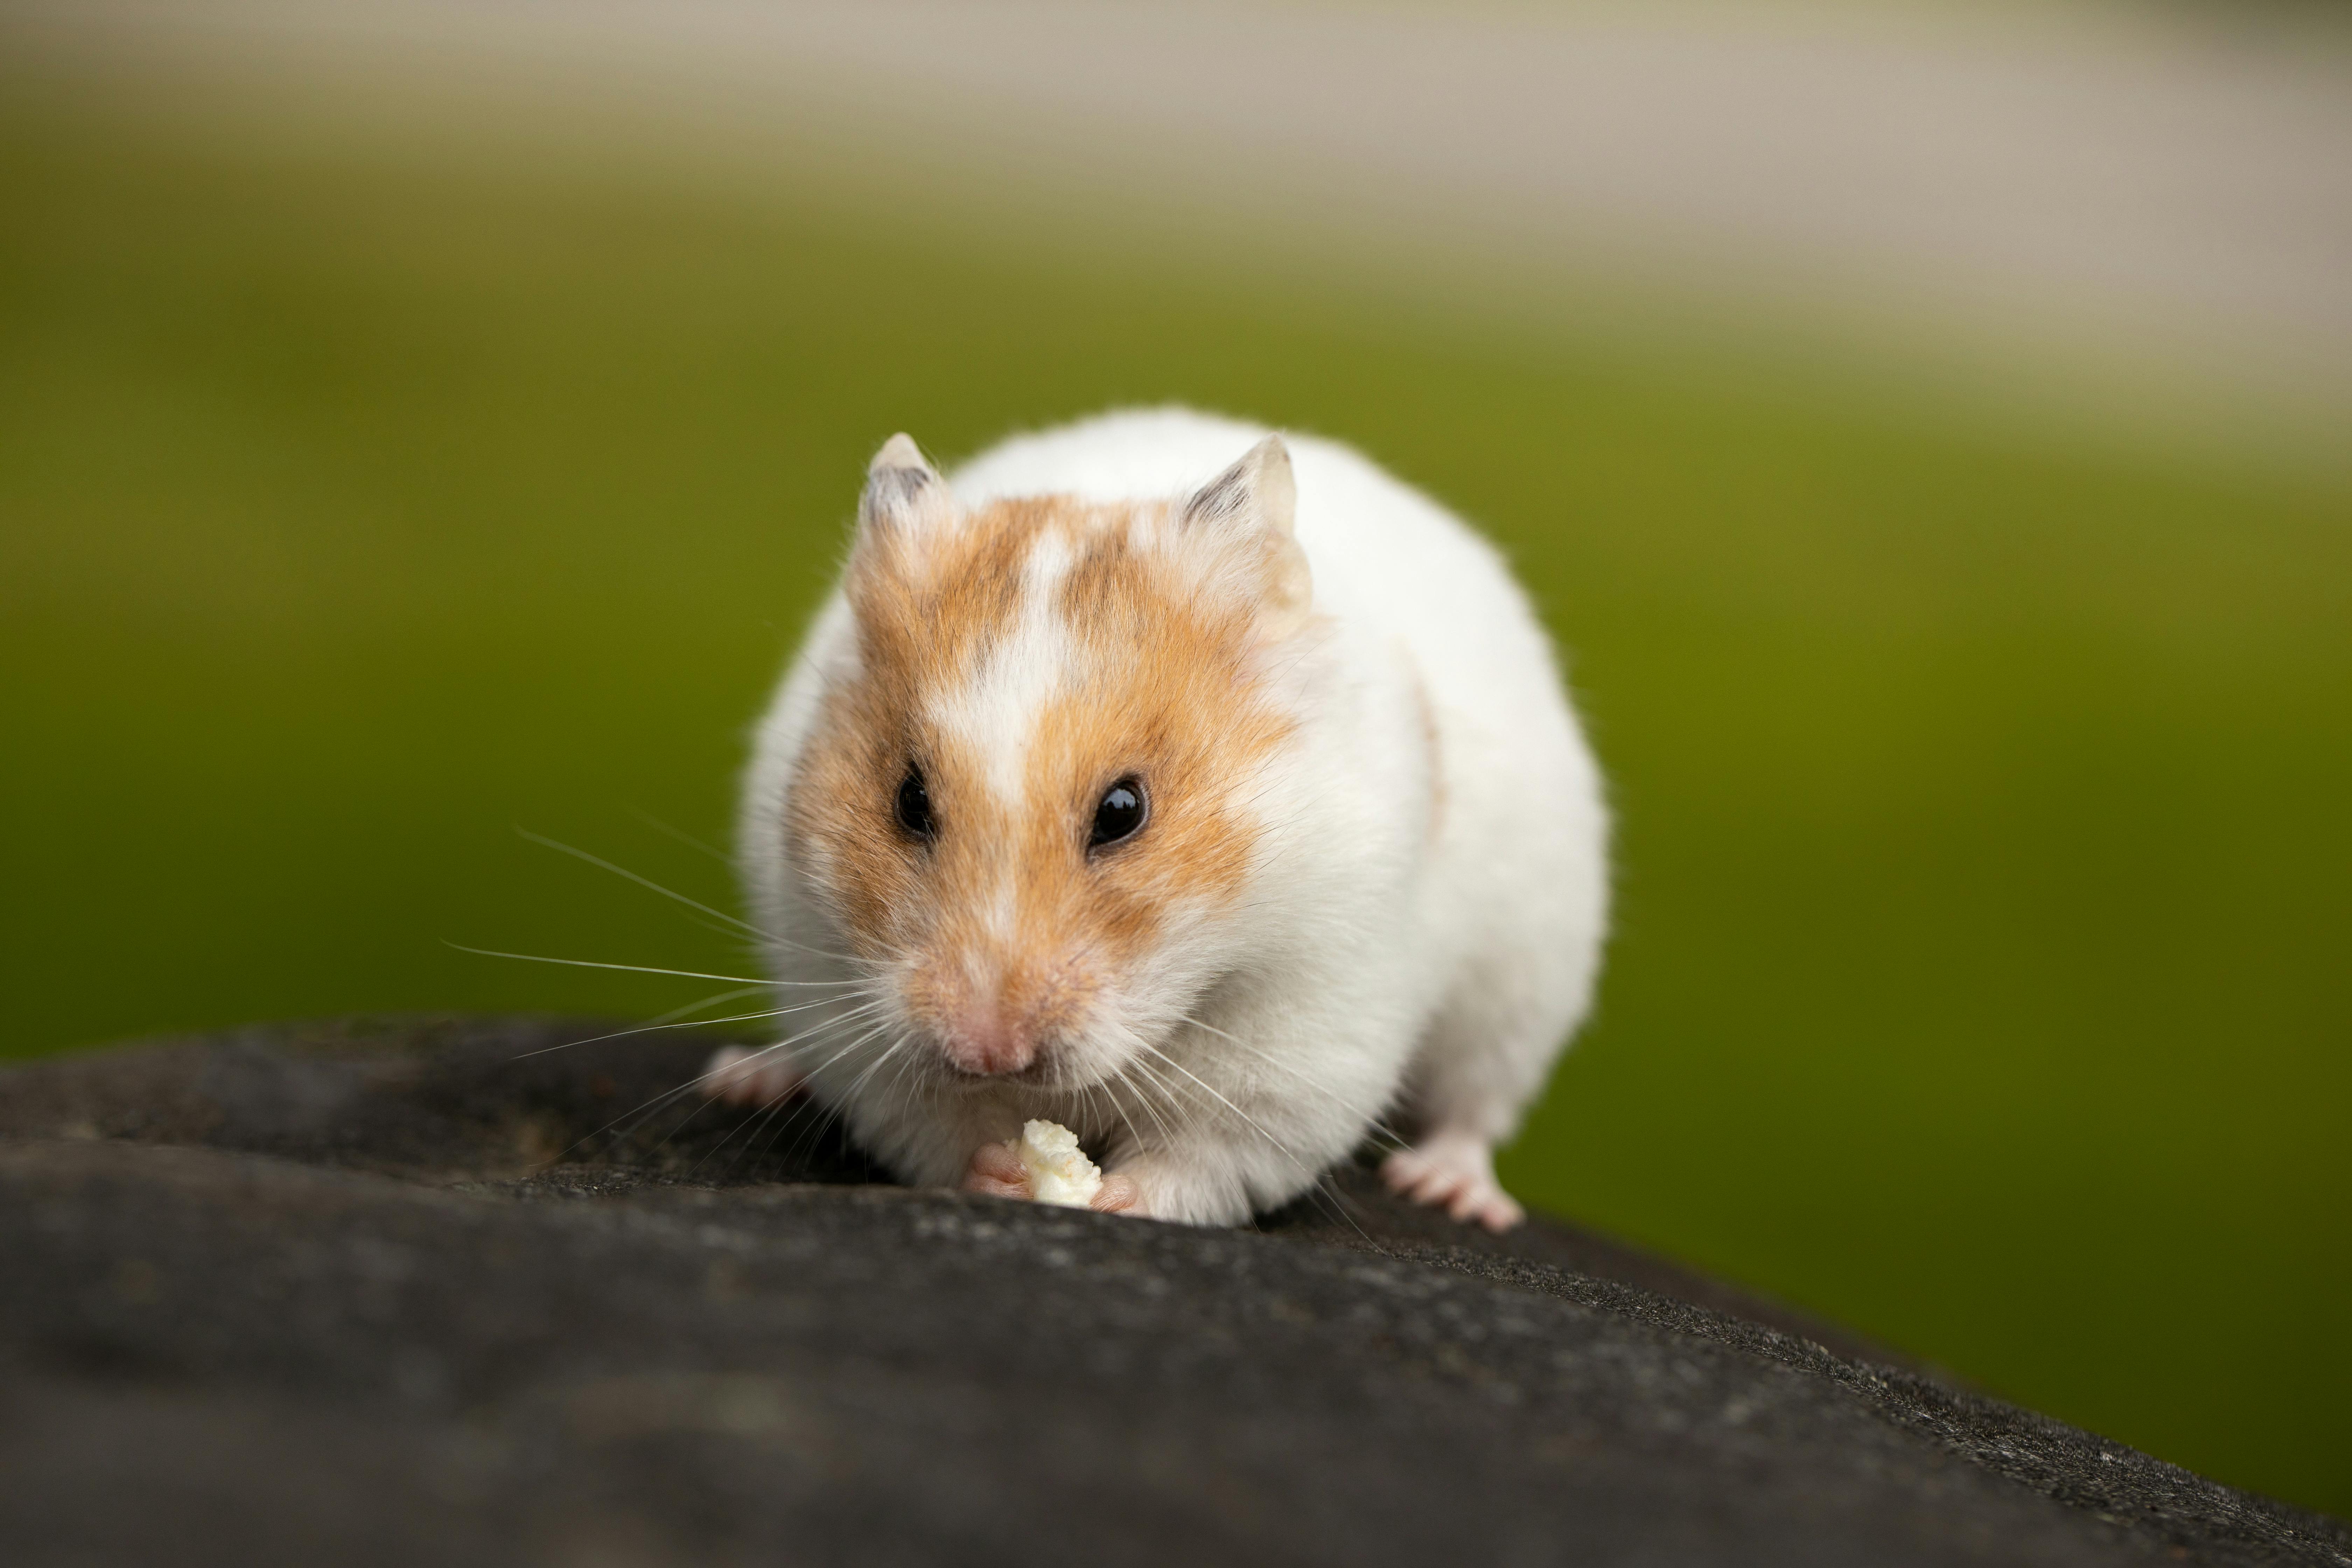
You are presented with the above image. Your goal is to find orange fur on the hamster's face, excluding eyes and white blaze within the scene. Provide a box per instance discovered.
[785,496,1291,1062]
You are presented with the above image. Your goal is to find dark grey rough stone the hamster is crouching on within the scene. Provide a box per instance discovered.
[0,1020,2352,1568]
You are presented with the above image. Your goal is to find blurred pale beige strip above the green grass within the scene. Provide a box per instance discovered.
[9,0,2352,447]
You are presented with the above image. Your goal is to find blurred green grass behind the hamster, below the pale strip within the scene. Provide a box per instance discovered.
[0,80,2352,1512]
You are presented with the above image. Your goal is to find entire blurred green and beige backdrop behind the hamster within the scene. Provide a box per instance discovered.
[0,0,2352,1512]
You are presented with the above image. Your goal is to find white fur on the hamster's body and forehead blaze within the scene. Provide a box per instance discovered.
[741,409,1609,1223]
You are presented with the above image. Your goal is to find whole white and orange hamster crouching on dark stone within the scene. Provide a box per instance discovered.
[703,409,1609,1230]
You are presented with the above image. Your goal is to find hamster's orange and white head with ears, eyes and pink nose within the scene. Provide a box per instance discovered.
[783,435,1312,1088]
